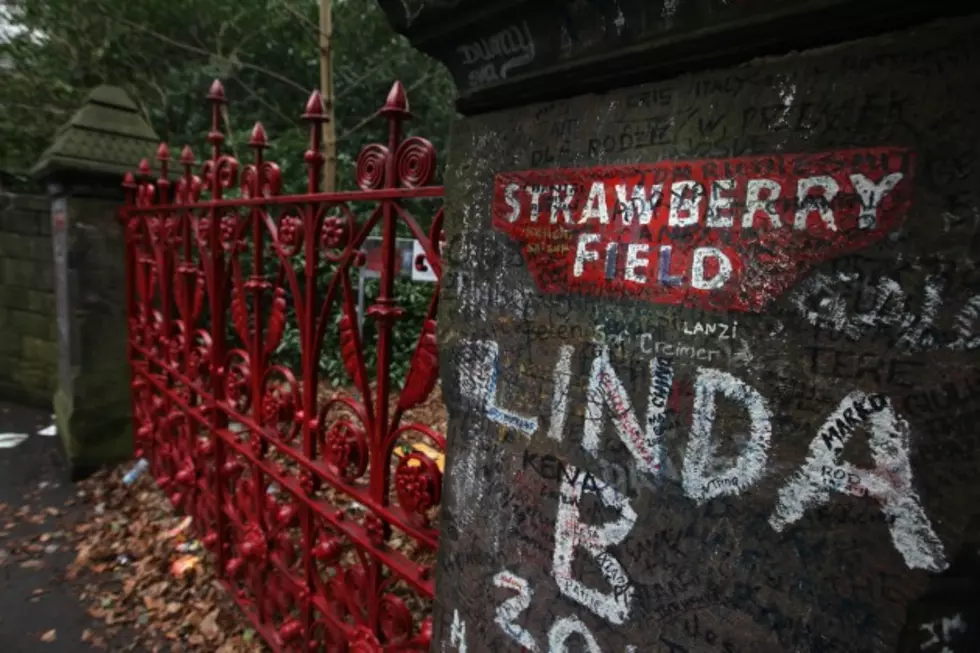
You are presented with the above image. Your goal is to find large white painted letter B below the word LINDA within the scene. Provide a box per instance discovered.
[552,460,637,625]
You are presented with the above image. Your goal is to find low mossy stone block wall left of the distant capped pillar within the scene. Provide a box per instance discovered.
[0,193,58,406]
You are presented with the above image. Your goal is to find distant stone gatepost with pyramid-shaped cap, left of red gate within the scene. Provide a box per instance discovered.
[32,86,158,478]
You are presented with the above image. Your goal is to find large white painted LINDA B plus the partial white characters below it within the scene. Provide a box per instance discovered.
[470,328,948,653]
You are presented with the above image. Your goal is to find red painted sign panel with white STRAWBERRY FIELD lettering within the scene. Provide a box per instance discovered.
[493,148,914,312]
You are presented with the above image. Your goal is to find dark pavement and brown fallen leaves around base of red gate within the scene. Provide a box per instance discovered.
[0,390,446,653]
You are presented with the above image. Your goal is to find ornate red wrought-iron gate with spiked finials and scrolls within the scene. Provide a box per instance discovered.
[121,81,445,651]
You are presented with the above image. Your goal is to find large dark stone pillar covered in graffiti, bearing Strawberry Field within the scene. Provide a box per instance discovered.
[382,0,980,653]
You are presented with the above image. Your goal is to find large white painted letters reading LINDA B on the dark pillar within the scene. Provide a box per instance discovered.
[460,341,947,572]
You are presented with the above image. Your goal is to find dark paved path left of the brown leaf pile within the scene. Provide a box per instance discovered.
[0,403,140,653]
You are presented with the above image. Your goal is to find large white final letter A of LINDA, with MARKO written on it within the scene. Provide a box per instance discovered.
[769,391,947,572]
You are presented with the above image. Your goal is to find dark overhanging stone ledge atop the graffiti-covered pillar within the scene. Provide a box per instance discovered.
[378,0,970,114]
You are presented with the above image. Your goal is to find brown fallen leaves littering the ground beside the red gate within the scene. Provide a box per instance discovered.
[65,384,446,653]
